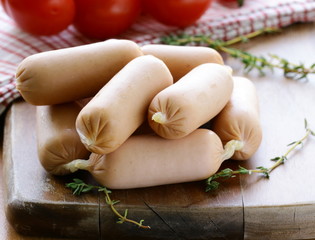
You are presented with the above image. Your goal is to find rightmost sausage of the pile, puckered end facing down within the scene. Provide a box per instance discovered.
[211,77,262,160]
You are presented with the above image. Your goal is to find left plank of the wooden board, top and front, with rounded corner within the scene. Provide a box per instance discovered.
[3,101,99,239]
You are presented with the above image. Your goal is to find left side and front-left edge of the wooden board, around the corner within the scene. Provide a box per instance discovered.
[2,102,99,239]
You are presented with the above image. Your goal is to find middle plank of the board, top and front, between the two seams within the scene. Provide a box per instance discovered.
[101,169,243,239]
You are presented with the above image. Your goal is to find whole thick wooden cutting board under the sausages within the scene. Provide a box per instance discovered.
[3,25,315,240]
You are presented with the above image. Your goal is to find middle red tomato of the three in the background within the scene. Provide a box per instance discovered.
[74,0,140,39]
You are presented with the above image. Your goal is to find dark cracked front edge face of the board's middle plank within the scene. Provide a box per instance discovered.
[100,203,244,240]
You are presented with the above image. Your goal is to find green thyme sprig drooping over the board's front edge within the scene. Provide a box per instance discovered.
[66,178,151,229]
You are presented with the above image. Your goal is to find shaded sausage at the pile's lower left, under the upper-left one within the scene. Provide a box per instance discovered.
[36,102,90,175]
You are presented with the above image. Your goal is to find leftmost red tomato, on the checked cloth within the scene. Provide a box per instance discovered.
[1,0,75,35]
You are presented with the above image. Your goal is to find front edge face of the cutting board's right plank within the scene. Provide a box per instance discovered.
[244,203,315,240]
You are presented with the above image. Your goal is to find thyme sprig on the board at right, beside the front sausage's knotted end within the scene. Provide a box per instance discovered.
[206,119,315,192]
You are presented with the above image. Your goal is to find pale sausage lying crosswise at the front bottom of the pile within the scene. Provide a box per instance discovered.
[67,129,223,189]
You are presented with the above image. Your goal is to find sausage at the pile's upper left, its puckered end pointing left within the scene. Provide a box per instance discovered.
[16,39,143,105]
